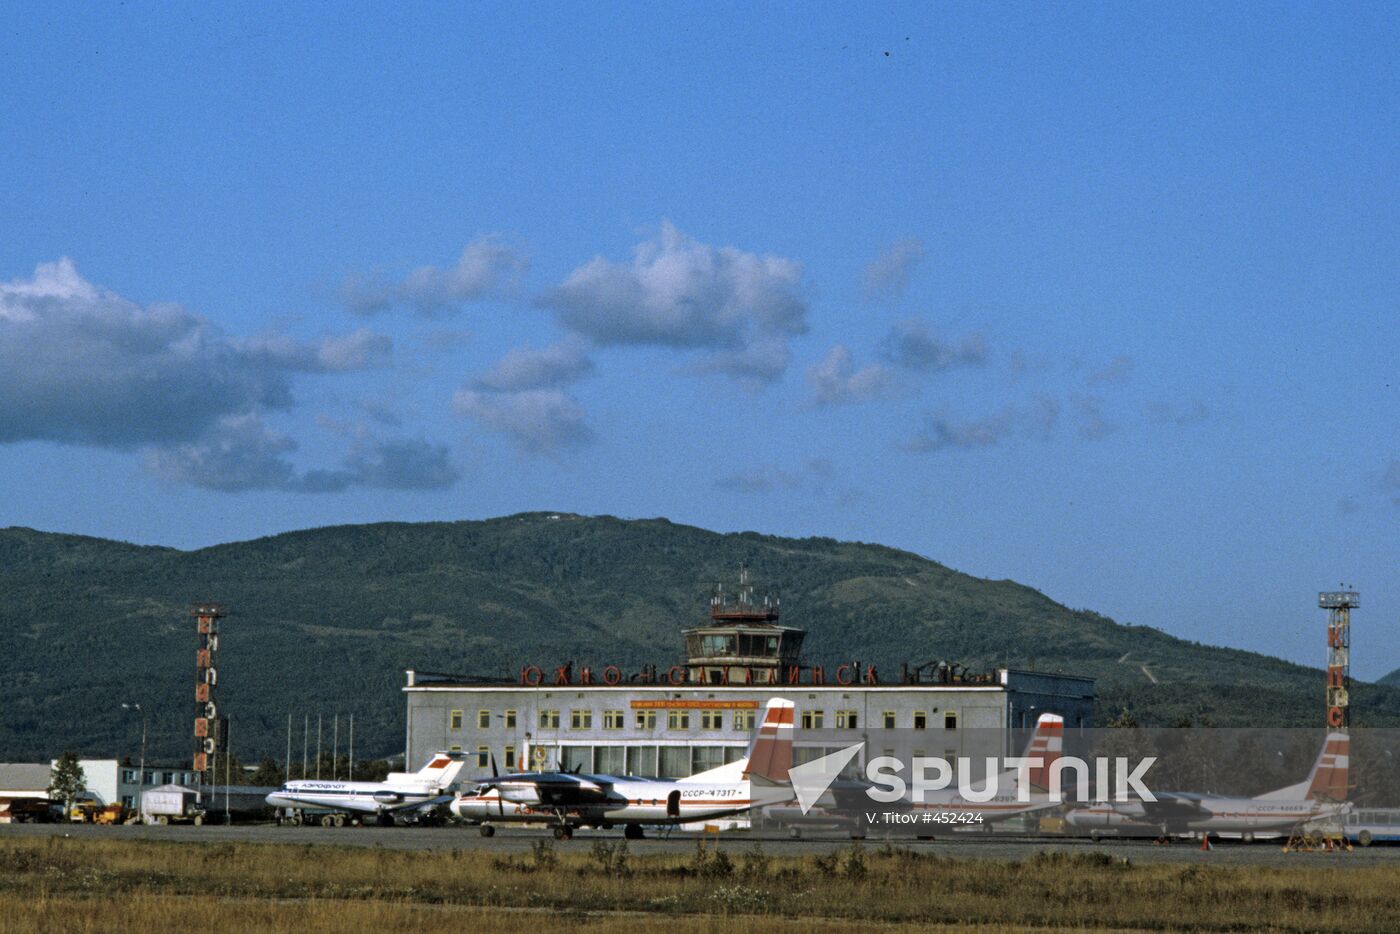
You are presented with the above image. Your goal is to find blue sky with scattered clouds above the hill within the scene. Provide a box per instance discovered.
[0,4,1400,676]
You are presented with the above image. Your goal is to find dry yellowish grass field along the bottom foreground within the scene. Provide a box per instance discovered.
[0,837,1400,934]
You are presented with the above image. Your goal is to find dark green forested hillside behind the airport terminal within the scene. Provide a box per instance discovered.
[0,514,1400,760]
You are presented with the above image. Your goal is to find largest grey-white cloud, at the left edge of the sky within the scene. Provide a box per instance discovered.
[0,253,391,448]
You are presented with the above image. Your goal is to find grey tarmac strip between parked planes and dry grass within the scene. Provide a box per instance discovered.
[0,823,1400,867]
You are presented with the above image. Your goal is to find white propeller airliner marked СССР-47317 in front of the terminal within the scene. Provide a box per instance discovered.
[451,697,794,840]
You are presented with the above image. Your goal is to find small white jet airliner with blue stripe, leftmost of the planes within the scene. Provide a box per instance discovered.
[267,752,466,826]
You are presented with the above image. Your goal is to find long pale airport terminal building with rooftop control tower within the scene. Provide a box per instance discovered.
[403,584,1093,779]
